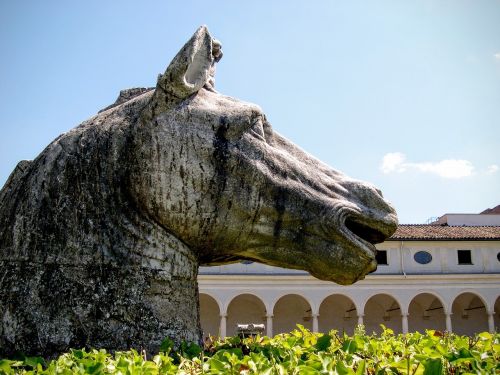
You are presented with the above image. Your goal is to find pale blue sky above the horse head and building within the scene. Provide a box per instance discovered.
[0,0,500,223]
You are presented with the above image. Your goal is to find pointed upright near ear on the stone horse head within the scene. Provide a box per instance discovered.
[157,26,214,99]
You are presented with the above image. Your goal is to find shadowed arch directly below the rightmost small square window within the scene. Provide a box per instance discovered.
[451,292,488,336]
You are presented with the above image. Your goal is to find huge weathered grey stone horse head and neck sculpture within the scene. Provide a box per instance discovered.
[0,27,397,355]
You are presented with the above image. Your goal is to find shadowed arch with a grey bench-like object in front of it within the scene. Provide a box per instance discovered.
[226,293,266,336]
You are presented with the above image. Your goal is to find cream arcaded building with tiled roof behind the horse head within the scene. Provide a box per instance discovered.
[198,214,500,336]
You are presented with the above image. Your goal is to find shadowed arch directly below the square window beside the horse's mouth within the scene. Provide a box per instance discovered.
[363,293,402,334]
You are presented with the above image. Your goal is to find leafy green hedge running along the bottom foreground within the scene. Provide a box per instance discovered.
[0,325,500,375]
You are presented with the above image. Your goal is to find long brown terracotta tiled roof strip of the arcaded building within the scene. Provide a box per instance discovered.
[388,224,500,241]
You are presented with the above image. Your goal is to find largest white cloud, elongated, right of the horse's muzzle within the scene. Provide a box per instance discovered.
[380,152,474,178]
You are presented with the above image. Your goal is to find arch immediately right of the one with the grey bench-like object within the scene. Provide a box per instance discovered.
[273,294,312,334]
